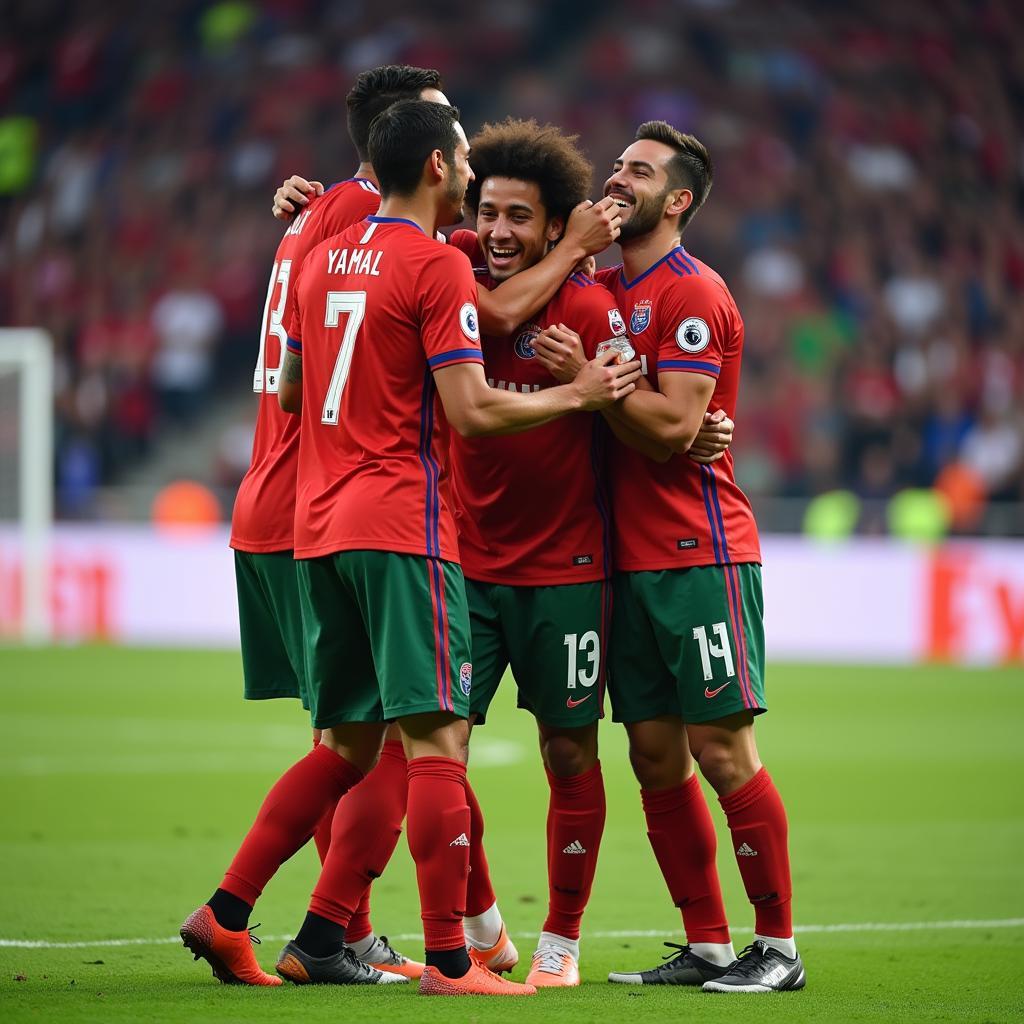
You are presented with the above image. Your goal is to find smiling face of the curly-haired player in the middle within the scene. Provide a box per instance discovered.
[476,176,563,281]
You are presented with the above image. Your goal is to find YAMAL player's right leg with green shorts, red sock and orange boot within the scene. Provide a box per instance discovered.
[339,551,534,995]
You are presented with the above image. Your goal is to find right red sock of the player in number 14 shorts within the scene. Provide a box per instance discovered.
[719,768,793,939]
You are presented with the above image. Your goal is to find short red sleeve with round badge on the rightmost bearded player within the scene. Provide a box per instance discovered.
[657,276,733,379]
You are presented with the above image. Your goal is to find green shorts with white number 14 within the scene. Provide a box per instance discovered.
[608,562,767,722]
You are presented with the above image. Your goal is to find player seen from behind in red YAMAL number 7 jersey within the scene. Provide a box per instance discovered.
[264,100,639,995]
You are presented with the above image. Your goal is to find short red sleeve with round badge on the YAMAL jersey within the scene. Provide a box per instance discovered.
[417,246,483,370]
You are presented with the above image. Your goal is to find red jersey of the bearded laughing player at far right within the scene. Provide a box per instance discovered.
[598,246,761,571]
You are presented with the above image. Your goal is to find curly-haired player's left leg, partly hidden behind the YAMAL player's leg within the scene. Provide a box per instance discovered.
[463,580,519,973]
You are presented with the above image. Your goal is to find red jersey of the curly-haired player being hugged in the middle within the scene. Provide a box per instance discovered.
[452,268,626,587]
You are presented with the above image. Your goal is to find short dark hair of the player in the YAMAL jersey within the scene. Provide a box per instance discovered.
[369,99,459,196]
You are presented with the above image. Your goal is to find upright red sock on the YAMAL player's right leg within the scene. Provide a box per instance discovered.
[409,757,470,952]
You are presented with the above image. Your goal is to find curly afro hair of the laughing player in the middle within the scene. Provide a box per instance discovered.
[466,118,594,219]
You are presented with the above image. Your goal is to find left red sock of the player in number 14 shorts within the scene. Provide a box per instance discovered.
[640,775,731,943]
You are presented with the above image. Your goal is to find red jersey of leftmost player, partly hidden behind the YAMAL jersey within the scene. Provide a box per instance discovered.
[230,178,381,554]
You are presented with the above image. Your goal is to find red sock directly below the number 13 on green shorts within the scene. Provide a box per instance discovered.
[544,762,604,939]
